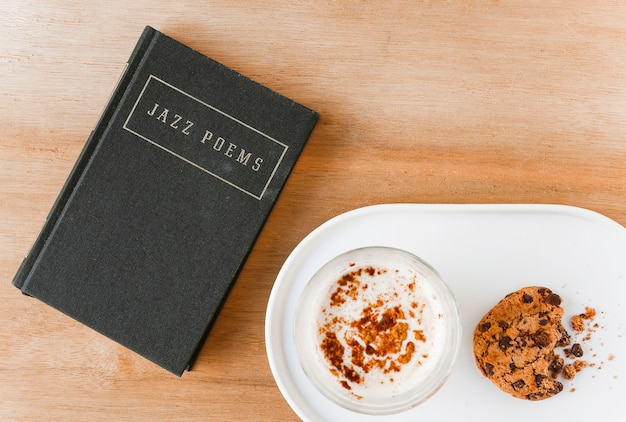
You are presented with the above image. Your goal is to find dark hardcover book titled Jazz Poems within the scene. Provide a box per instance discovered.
[13,27,318,376]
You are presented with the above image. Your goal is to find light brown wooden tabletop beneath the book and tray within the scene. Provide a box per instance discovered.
[0,0,626,421]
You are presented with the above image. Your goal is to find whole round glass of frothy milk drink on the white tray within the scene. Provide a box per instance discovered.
[293,246,461,415]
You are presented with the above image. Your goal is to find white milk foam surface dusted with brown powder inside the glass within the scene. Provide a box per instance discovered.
[315,266,446,399]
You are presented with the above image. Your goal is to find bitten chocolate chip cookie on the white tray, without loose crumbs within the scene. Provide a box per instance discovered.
[474,286,570,400]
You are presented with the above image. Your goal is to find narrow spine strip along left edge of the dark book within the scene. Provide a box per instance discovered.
[13,26,158,292]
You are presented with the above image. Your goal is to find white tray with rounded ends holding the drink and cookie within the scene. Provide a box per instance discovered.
[265,204,626,422]
